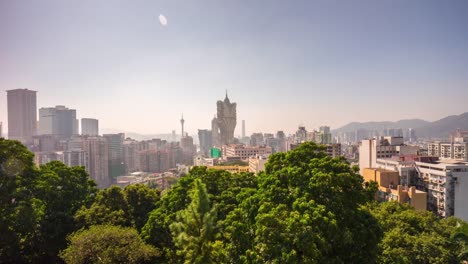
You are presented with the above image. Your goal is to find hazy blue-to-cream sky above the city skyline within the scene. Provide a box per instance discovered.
[0,0,468,134]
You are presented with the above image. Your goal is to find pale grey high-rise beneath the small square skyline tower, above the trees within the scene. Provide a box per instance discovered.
[83,137,112,188]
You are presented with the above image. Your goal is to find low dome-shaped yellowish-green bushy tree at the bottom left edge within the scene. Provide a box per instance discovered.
[60,225,159,264]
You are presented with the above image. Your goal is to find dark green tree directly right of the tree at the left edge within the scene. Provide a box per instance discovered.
[35,161,97,261]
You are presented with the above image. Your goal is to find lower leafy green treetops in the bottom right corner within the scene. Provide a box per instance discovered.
[371,202,466,264]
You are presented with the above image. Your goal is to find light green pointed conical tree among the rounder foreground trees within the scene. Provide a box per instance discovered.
[170,179,226,263]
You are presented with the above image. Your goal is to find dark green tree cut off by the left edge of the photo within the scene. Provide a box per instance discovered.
[0,138,40,262]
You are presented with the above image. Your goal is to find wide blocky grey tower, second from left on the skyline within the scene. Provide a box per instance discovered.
[38,105,77,139]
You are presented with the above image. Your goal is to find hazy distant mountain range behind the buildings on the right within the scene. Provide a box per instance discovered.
[332,112,468,138]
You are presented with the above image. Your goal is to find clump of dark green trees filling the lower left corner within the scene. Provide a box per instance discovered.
[0,139,96,262]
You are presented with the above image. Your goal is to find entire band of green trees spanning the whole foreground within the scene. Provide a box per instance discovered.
[0,139,468,263]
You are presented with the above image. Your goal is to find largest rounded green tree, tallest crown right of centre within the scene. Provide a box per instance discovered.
[247,142,382,263]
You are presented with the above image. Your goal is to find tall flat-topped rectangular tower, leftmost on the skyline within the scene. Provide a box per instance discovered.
[7,89,37,144]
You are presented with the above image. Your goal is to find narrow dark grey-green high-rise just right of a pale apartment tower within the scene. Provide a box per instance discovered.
[103,133,125,178]
